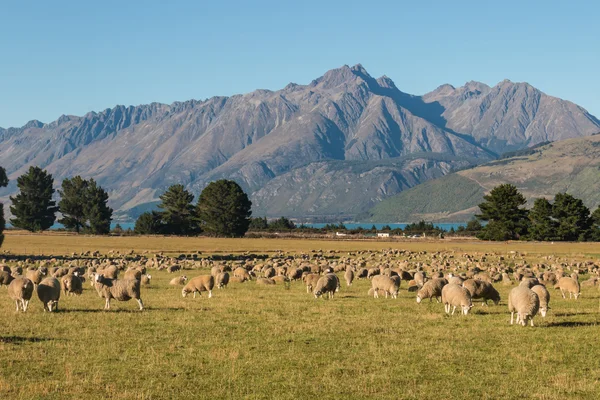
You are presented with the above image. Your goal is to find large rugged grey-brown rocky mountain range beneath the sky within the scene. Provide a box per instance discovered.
[0,65,600,216]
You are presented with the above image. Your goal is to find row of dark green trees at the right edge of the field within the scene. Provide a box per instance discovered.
[476,184,600,241]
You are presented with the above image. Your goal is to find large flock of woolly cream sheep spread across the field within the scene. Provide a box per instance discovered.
[0,250,600,326]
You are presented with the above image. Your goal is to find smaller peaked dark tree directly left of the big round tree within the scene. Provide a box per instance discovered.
[158,185,198,235]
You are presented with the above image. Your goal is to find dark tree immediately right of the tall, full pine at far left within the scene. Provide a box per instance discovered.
[58,175,89,233]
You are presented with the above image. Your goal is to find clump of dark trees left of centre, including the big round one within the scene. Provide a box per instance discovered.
[134,179,252,237]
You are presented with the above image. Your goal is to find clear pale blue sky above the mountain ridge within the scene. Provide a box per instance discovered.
[0,0,600,128]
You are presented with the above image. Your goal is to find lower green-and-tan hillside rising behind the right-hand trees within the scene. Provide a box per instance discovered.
[363,134,600,222]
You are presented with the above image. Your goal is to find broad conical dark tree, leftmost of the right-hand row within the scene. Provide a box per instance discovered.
[476,183,529,240]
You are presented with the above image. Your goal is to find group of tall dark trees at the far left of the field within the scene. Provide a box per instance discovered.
[0,167,113,234]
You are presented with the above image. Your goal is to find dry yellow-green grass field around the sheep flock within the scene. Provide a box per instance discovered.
[0,234,600,399]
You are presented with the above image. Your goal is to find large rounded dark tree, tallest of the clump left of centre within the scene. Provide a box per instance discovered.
[196,179,252,237]
